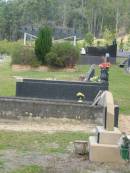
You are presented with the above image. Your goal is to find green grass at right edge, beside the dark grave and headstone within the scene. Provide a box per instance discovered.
[109,66,130,114]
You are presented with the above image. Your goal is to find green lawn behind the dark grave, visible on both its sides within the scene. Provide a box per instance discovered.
[0,59,130,114]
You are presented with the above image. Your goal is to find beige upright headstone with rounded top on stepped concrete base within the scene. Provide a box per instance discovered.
[89,91,124,163]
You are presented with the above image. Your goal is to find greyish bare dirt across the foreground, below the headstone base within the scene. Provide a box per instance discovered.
[0,150,130,173]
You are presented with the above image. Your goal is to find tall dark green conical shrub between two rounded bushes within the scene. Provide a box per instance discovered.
[35,27,52,64]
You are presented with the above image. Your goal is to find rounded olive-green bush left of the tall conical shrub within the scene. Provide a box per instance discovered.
[12,46,40,67]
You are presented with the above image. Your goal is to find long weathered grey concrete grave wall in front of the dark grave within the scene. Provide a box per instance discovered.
[0,97,104,125]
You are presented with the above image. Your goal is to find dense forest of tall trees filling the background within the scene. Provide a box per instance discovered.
[0,0,130,40]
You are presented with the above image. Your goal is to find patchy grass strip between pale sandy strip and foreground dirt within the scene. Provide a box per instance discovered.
[0,131,89,154]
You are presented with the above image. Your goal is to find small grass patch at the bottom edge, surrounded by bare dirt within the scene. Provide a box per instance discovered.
[11,165,44,173]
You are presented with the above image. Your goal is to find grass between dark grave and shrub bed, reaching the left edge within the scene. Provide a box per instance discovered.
[0,59,88,96]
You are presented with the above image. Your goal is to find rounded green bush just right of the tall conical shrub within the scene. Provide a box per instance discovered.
[46,42,79,67]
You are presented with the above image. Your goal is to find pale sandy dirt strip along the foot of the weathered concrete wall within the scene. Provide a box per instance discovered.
[0,118,95,133]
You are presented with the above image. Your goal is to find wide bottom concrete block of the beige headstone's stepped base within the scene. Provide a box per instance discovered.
[89,136,124,163]
